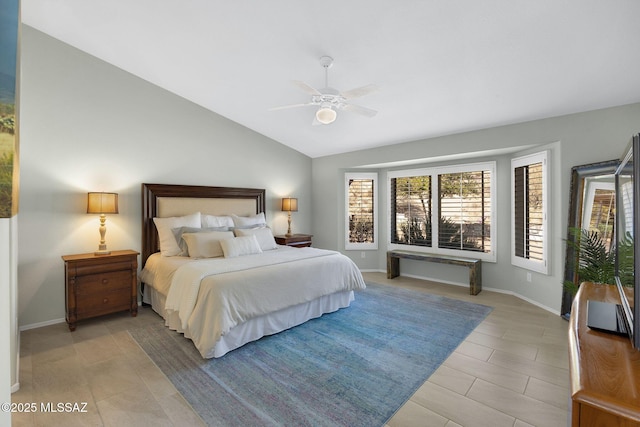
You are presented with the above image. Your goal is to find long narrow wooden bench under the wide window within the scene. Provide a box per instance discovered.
[387,250,482,295]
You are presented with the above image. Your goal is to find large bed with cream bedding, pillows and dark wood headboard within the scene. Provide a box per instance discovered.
[140,184,365,358]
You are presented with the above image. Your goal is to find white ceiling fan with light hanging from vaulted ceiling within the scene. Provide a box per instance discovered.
[270,56,378,125]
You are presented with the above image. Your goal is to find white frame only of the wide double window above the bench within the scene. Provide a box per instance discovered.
[387,161,498,262]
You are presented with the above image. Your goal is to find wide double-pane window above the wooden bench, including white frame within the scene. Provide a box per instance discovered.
[389,162,495,261]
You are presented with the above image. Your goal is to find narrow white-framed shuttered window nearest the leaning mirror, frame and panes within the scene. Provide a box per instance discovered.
[511,151,548,274]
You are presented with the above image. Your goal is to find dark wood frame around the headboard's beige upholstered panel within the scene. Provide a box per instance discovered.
[141,184,265,266]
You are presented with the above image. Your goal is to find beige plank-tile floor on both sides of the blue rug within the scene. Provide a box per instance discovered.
[12,273,569,427]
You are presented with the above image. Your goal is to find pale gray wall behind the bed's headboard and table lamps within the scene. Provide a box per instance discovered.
[18,26,312,326]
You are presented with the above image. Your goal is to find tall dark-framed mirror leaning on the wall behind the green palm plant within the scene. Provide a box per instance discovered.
[561,159,620,319]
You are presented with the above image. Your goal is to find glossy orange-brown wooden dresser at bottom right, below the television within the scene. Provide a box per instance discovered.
[569,283,640,427]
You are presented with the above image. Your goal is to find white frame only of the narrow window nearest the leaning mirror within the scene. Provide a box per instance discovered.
[510,150,550,274]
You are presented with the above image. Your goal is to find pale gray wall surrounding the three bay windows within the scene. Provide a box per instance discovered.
[312,104,640,313]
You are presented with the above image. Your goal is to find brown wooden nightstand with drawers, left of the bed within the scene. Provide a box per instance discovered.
[62,250,138,331]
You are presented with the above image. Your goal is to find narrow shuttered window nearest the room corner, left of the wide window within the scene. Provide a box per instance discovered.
[345,173,378,250]
